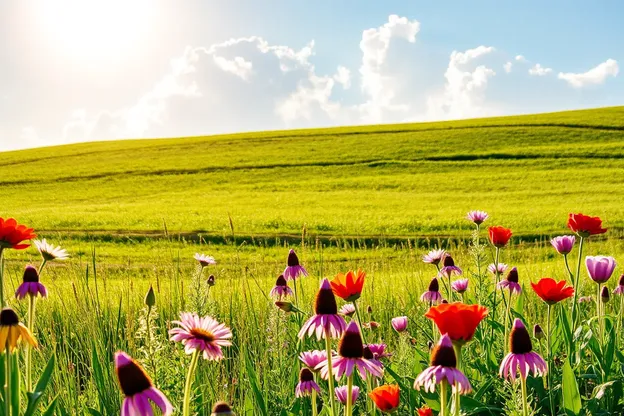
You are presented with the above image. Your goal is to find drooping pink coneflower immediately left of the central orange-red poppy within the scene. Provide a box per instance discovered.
[299,279,346,340]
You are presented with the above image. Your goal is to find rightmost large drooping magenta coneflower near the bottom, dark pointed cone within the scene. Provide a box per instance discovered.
[499,318,548,382]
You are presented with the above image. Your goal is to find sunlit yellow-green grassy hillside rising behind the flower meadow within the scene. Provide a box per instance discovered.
[0,107,624,236]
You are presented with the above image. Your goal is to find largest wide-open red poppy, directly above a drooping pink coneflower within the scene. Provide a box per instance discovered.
[425,302,488,342]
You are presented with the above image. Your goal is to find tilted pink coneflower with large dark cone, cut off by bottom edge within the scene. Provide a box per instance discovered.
[115,351,173,416]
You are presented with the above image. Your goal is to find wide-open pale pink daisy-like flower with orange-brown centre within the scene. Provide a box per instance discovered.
[169,312,232,361]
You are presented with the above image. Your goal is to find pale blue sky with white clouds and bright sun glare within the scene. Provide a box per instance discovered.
[0,0,624,151]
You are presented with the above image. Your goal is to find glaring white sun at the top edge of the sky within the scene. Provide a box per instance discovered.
[35,0,151,59]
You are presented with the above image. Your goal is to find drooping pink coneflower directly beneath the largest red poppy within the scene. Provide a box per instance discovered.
[414,334,472,394]
